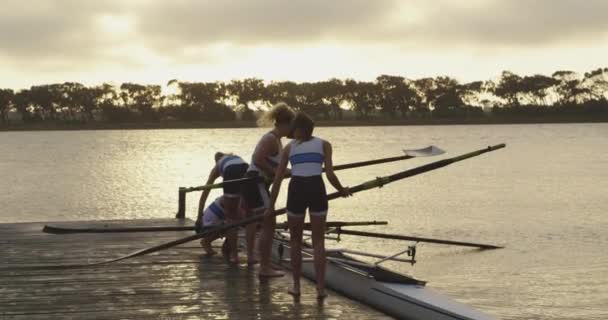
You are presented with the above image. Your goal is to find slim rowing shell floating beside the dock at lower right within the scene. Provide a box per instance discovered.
[272,233,495,320]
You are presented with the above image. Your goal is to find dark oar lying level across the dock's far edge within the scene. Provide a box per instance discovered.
[42,221,388,234]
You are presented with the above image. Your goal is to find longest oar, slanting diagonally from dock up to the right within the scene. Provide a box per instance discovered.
[70,144,505,267]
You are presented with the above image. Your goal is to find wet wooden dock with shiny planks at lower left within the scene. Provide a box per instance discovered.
[0,219,388,320]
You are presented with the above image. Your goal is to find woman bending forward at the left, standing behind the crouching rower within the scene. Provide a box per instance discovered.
[198,152,249,264]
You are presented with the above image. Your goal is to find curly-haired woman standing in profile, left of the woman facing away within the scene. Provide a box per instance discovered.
[242,102,295,278]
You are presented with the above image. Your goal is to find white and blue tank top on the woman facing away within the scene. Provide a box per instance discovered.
[289,137,325,177]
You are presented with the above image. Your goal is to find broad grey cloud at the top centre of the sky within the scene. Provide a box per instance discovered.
[138,0,397,45]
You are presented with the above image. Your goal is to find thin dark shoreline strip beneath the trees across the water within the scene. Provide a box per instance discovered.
[0,116,608,131]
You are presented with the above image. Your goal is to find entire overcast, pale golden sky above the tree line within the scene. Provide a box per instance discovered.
[0,0,608,87]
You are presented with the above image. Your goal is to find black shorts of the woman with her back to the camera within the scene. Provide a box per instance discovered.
[287,176,327,216]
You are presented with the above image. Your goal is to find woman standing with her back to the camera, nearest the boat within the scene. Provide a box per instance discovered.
[265,113,352,298]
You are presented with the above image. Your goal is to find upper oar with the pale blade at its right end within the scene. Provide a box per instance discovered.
[184,146,445,192]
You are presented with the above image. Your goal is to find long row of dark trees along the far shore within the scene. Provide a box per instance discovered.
[0,68,608,124]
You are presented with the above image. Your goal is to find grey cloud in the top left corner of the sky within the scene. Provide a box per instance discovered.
[0,0,128,71]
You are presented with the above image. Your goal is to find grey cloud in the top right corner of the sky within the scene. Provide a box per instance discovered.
[408,0,608,47]
